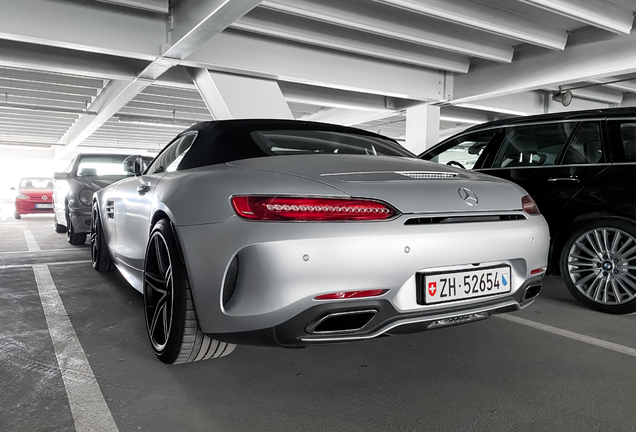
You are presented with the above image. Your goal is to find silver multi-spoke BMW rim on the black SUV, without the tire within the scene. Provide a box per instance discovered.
[567,227,636,305]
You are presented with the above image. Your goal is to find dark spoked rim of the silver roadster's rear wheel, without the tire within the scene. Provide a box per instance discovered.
[144,232,174,352]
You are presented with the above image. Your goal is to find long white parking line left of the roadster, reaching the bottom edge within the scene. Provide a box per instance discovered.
[33,264,119,432]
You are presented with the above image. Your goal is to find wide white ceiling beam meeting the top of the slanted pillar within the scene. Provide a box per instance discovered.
[183,30,445,101]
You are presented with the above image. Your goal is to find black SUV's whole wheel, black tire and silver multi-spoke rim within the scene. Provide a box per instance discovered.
[560,218,636,314]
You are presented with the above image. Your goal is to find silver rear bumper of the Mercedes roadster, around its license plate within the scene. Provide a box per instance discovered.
[176,211,549,340]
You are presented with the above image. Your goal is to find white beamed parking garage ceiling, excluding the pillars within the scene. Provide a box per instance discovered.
[0,0,636,159]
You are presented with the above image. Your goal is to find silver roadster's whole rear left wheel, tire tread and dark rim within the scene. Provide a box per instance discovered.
[143,219,236,364]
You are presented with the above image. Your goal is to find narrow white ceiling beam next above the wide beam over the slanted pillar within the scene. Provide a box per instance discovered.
[232,8,469,73]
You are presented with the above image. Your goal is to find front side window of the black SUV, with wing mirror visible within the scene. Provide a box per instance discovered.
[425,129,497,169]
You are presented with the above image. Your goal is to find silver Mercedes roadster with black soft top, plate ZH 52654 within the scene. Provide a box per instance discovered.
[91,120,549,363]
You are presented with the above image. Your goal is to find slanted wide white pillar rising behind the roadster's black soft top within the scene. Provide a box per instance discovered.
[188,68,294,120]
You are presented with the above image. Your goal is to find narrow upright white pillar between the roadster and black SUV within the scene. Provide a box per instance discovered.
[405,104,440,154]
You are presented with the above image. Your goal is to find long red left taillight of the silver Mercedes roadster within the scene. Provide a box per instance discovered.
[232,196,397,221]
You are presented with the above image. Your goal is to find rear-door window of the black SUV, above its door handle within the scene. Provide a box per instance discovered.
[493,122,577,168]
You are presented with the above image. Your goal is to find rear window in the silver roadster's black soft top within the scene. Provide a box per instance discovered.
[252,130,414,157]
